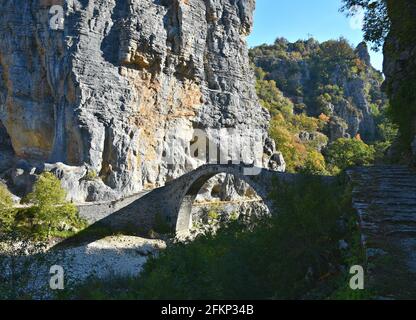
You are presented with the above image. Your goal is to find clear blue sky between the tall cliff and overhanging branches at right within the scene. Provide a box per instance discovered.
[248,0,383,70]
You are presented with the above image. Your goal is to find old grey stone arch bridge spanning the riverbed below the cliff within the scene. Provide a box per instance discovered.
[73,164,298,240]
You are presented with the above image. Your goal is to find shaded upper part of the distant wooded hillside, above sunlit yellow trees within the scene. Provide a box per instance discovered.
[250,38,386,142]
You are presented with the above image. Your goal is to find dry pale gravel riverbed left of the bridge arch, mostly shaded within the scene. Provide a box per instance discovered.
[0,236,166,299]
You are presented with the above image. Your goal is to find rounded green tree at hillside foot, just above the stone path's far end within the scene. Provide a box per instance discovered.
[326,138,375,170]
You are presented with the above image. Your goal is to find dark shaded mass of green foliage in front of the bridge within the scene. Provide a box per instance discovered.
[61,177,370,299]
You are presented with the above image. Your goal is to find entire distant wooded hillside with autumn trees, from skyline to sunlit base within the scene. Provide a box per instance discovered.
[250,38,395,172]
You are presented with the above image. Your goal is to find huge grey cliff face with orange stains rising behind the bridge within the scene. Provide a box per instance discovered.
[0,0,280,201]
